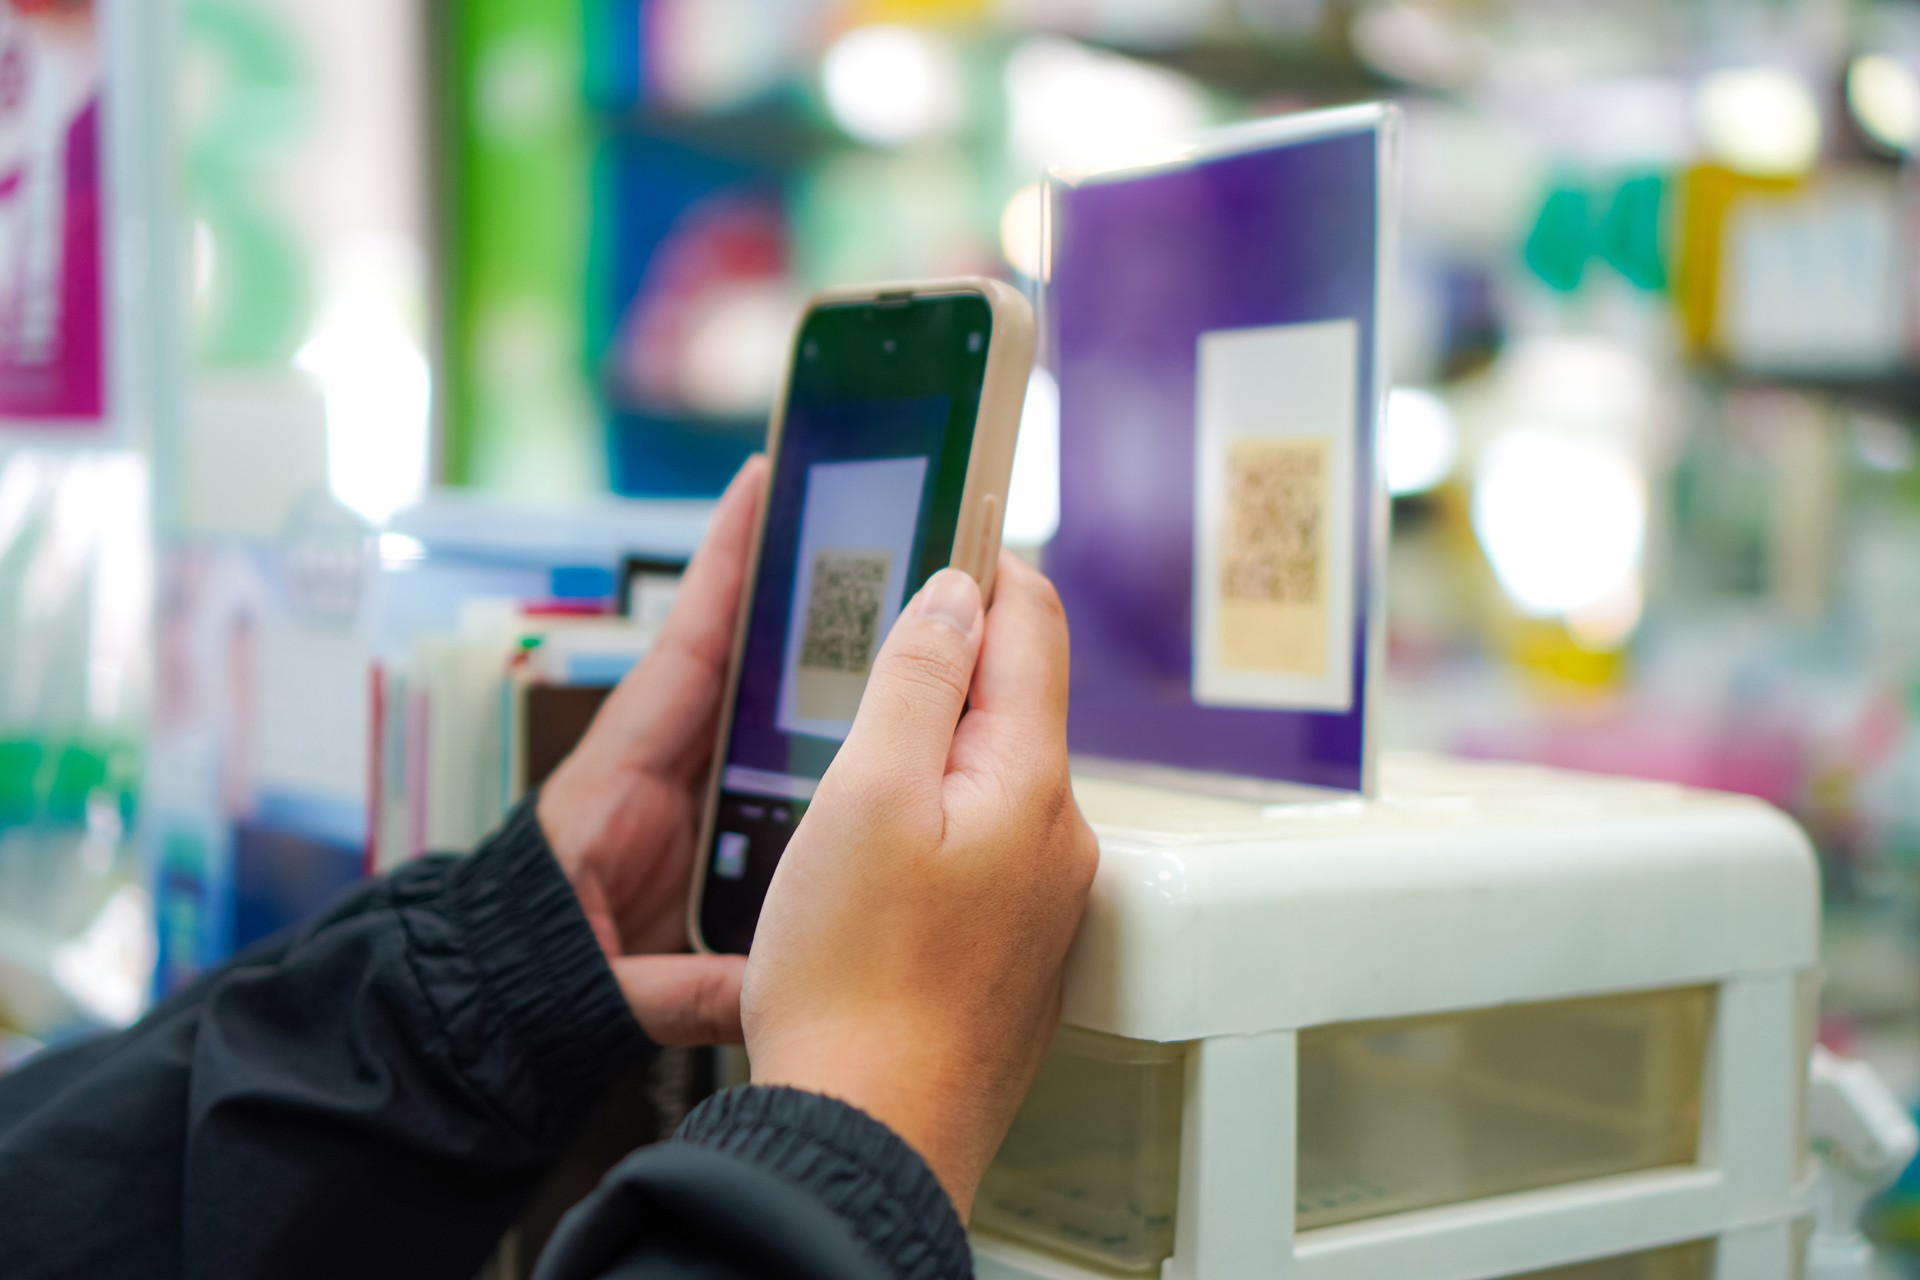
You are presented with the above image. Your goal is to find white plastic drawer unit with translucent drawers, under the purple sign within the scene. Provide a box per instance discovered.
[973,758,1818,1280]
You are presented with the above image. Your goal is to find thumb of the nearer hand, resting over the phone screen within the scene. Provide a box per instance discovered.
[835,568,985,785]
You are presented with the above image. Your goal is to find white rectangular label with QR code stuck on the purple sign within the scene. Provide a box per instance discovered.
[1192,320,1359,712]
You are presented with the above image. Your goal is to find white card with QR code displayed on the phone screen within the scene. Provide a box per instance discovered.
[776,457,927,741]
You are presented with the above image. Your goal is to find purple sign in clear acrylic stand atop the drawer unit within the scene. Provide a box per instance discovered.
[1044,106,1398,791]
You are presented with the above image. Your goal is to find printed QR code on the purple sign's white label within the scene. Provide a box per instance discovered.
[1221,439,1327,604]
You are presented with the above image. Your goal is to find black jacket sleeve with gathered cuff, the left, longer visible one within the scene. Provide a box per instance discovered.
[0,810,645,1280]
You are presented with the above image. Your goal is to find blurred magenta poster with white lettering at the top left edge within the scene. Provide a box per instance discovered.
[0,0,108,436]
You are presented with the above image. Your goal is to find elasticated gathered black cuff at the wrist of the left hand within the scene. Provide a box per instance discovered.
[409,800,651,1136]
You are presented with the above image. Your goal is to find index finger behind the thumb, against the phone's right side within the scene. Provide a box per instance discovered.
[970,551,1069,735]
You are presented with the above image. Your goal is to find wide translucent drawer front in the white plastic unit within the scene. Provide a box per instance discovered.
[1296,986,1713,1228]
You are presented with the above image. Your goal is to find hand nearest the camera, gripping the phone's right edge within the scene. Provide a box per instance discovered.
[741,557,1098,1221]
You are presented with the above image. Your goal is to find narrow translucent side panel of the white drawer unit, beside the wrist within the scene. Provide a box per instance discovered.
[973,1027,1187,1272]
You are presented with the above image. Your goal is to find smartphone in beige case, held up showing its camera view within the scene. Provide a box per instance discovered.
[687,278,1033,954]
